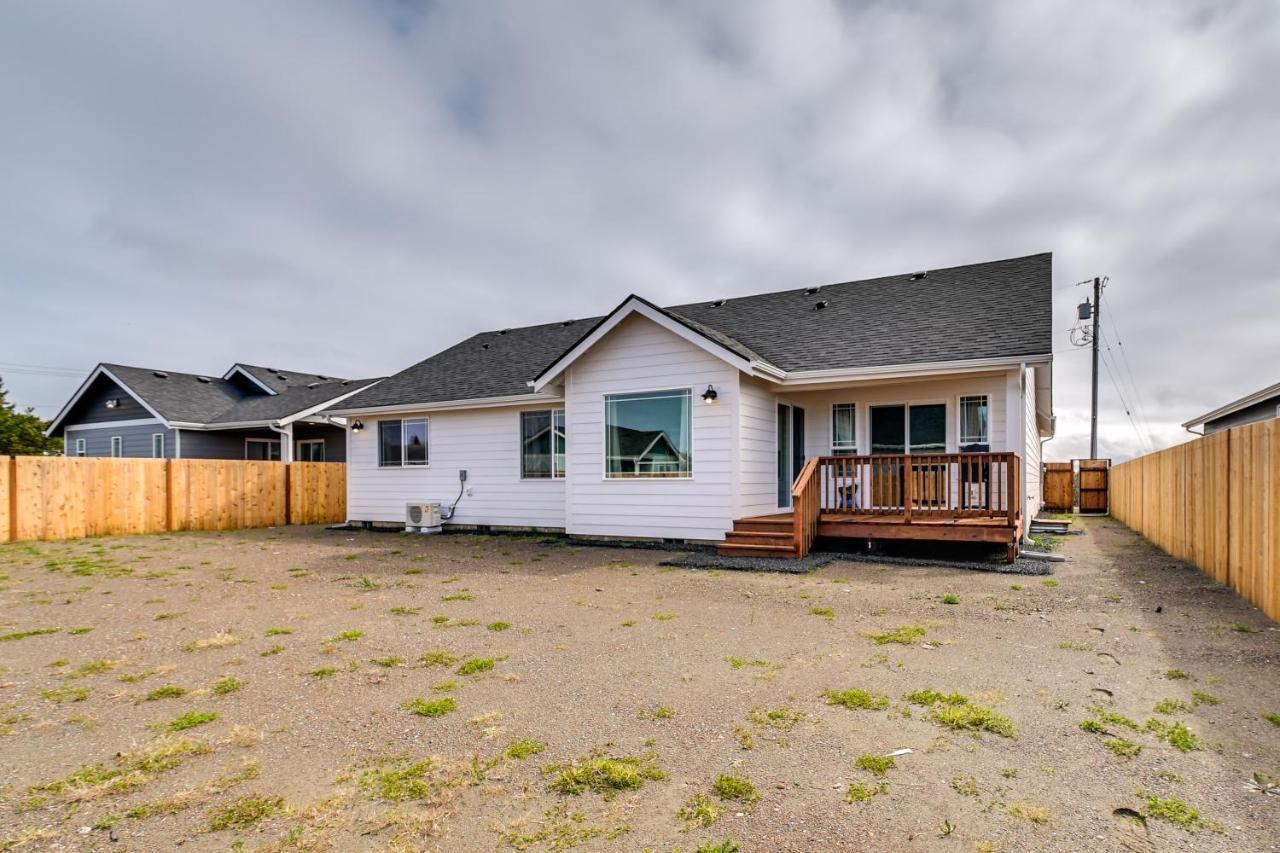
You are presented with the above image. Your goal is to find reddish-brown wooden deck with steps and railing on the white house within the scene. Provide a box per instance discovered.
[719,453,1023,561]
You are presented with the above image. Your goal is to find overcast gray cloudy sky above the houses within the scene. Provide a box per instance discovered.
[0,0,1280,459]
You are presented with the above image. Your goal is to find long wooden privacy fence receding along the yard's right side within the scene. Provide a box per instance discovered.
[1111,420,1280,620]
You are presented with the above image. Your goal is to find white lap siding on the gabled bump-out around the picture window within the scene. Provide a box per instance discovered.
[564,316,739,539]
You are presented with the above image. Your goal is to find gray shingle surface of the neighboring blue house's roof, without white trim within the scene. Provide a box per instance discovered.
[102,364,376,425]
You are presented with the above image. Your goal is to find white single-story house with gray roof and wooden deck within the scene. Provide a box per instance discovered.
[330,254,1053,556]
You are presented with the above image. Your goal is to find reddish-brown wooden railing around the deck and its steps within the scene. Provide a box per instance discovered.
[791,452,1020,556]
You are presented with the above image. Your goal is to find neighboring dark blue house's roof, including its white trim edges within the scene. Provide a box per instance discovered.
[47,362,378,434]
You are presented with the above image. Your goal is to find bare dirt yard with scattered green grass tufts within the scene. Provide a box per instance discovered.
[0,520,1280,853]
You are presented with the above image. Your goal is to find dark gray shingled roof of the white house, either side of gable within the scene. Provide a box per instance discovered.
[335,252,1053,409]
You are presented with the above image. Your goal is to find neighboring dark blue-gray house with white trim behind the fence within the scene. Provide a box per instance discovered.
[46,364,378,462]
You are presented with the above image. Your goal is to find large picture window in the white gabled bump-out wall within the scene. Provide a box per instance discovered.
[604,388,694,479]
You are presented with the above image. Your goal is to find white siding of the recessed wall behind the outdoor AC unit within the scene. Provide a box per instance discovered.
[347,406,572,528]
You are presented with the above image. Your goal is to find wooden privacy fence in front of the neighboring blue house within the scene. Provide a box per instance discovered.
[0,456,347,542]
